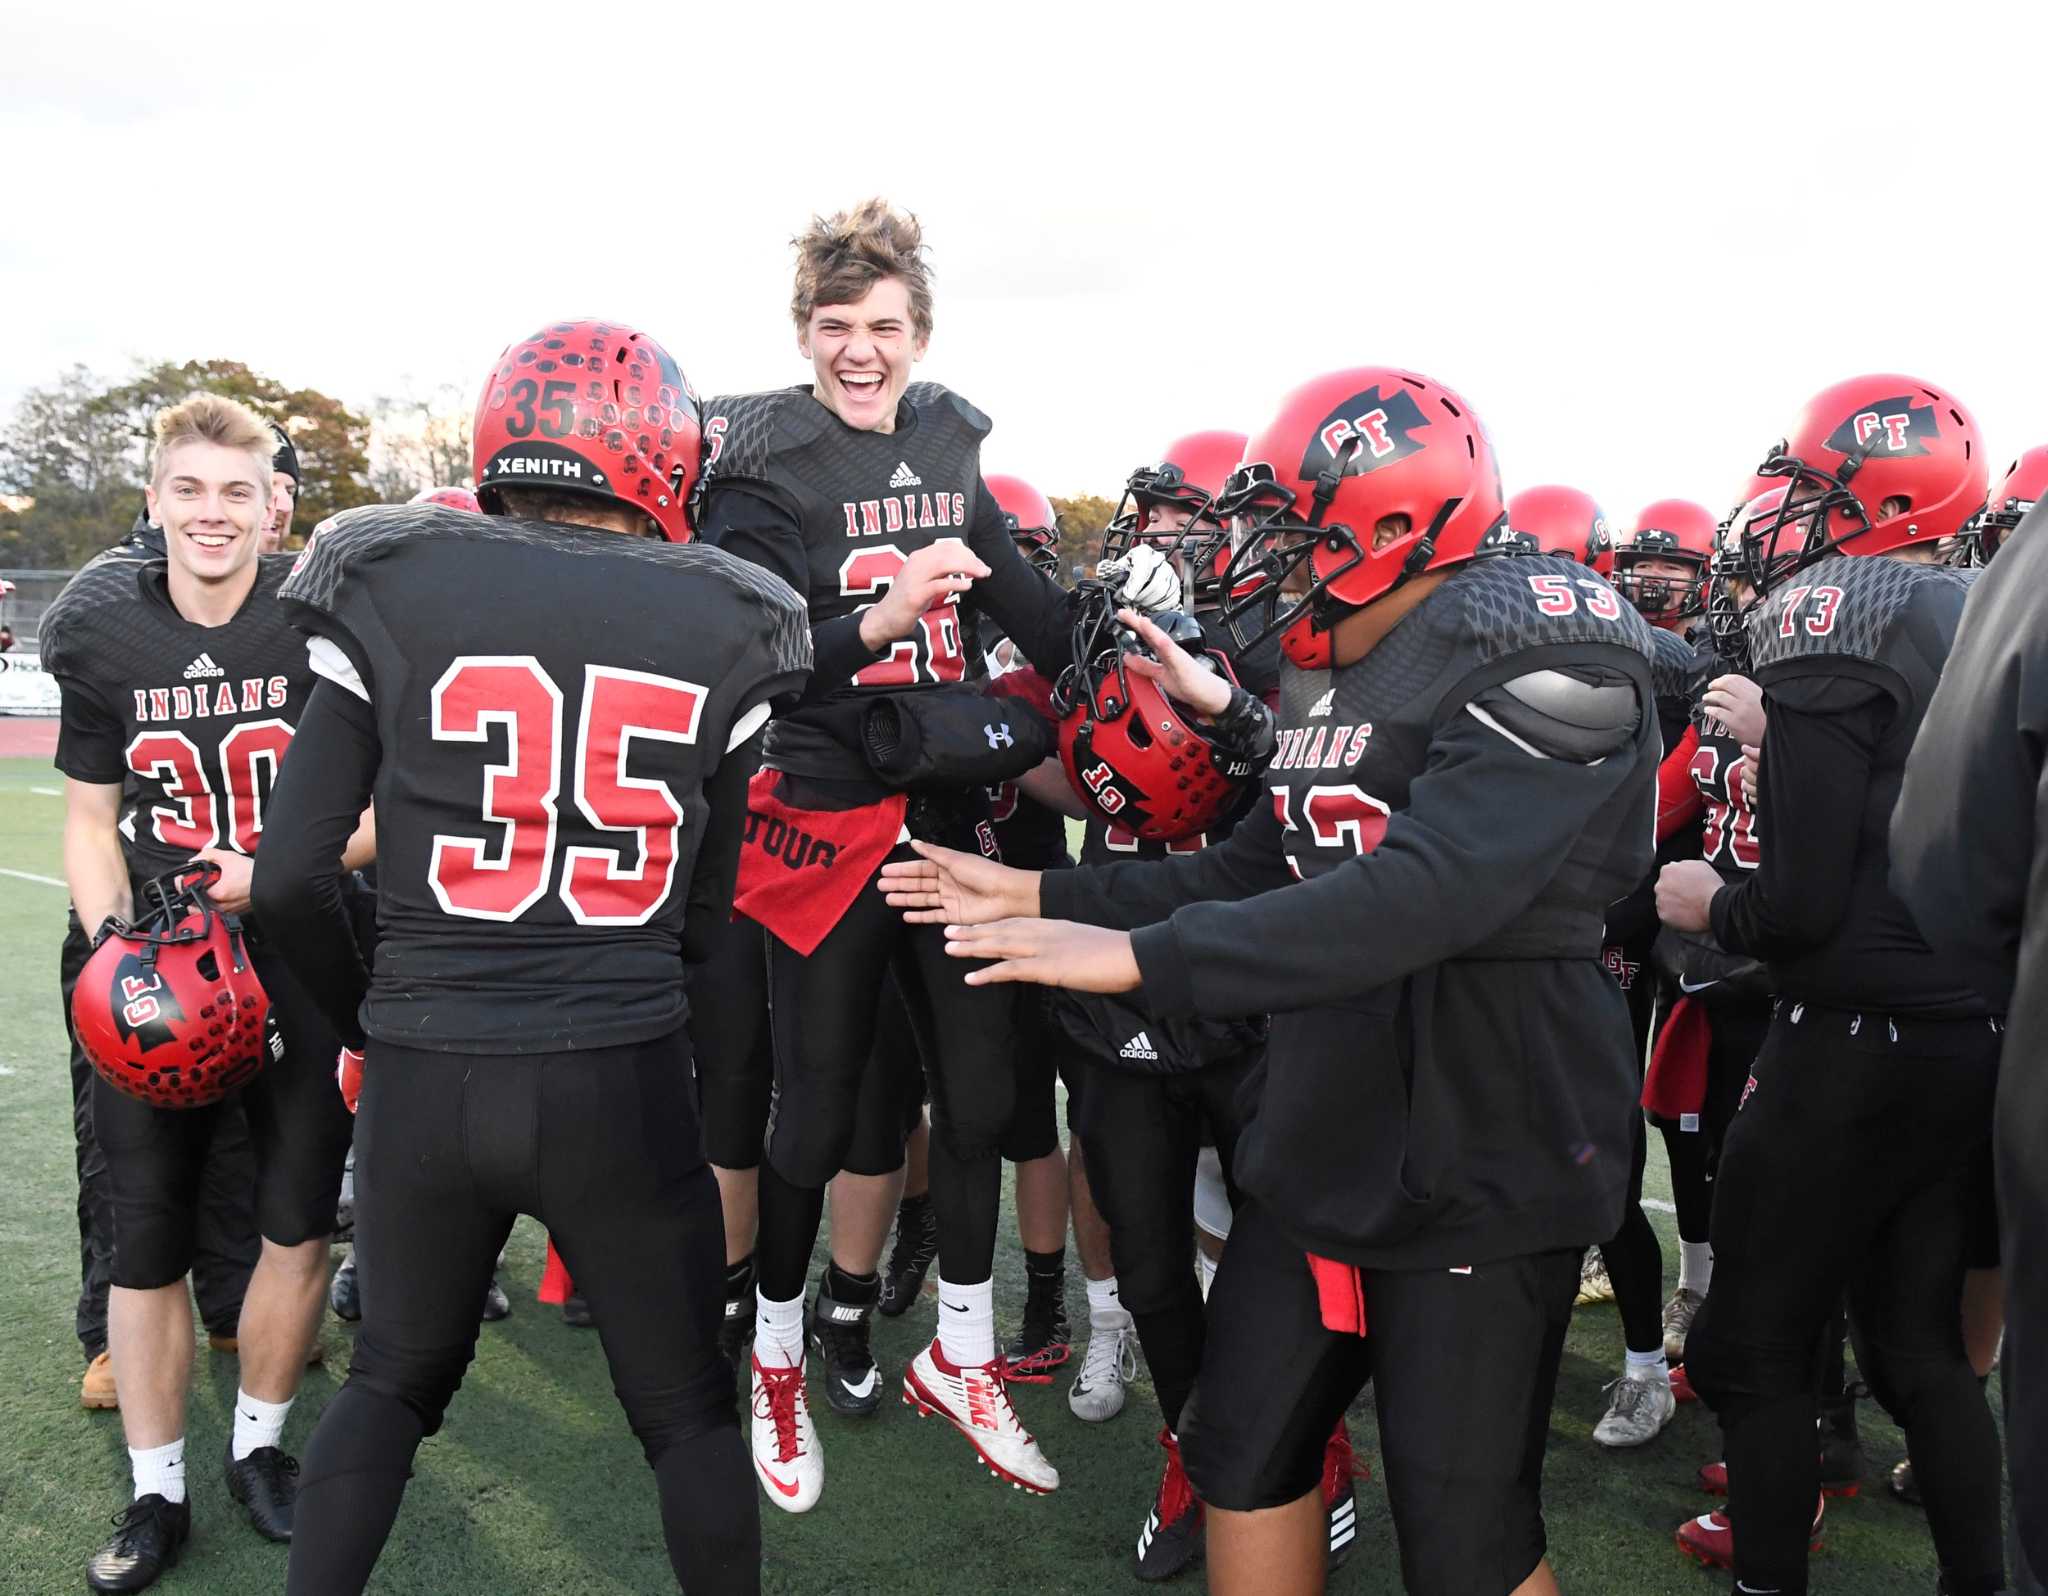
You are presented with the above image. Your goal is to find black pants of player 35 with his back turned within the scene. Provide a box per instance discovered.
[287,1033,760,1596]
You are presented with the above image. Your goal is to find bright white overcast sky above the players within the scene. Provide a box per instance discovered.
[0,0,2048,522]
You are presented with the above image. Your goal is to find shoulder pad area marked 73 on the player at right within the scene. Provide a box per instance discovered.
[1749,555,1970,678]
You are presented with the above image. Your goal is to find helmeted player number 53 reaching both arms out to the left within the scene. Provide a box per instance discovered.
[883,367,1657,1596]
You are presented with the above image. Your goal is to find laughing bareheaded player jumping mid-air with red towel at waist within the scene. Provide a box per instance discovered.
[688,201,1178,1512]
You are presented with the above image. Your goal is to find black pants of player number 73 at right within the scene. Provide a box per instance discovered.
[1686,1002,2003,1592]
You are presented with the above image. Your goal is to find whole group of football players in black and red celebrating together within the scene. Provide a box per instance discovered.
[41,201,2048,1596]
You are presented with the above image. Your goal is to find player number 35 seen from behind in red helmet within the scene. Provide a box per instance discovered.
[256,320,811,1596]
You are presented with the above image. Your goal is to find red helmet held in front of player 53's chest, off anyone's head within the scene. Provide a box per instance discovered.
[1053,582,1257,842]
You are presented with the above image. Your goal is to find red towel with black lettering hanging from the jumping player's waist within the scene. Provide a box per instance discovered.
[733,770,909,957]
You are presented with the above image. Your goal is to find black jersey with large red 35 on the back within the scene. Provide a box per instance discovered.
[283,506,811,1053]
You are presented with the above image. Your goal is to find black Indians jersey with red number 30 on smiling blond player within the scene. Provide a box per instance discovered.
[41,545,313,879]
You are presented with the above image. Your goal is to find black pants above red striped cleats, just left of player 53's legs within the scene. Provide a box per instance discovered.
[1077,1055,1253,1434]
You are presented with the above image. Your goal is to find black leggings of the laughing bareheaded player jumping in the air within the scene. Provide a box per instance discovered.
[756,848,1016,1301]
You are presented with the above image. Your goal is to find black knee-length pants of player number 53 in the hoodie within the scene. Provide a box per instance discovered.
[1179,1201,1579,1596]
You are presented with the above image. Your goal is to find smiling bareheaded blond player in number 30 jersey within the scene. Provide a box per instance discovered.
[43,393,369,1590]
